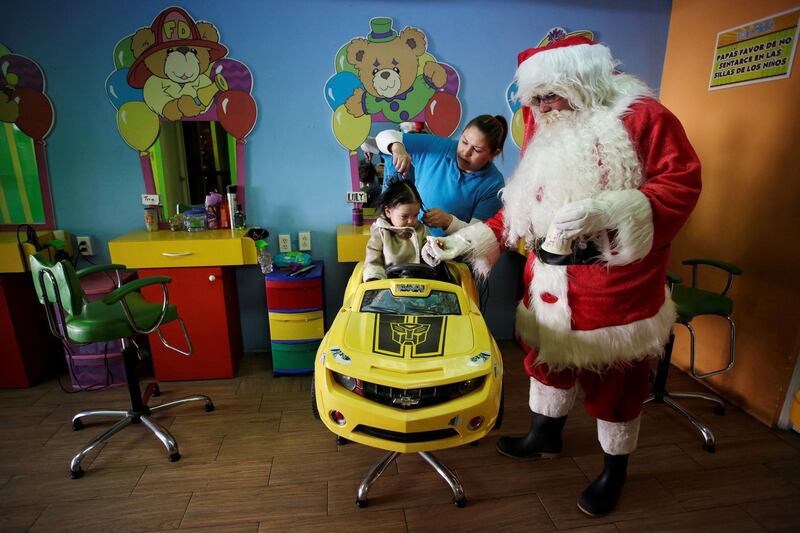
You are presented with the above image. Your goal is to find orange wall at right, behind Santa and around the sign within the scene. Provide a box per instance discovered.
[661,0,800,426]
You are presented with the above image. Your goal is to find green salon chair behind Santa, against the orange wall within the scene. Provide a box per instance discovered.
[644,259,742,453]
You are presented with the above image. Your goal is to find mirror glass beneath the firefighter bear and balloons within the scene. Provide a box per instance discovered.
[151,120,238,220]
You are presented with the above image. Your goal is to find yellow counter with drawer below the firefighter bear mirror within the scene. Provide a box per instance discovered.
[108,229,258,268]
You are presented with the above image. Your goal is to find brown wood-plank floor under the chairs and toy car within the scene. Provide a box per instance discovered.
[0,343,800,533]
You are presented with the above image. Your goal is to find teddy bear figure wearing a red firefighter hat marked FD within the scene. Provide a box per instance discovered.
[128,7,228,120]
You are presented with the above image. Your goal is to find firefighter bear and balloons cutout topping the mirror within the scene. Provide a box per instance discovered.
[106,7,257,148]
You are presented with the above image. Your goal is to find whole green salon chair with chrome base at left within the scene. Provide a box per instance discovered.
[30,254,214,479]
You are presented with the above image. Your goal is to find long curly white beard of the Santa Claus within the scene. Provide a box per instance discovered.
[502,108,643,246]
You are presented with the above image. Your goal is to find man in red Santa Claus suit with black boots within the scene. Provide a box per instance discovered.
[425,36,700,516]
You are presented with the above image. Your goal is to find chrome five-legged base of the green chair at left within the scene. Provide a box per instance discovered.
[69,383,214,479]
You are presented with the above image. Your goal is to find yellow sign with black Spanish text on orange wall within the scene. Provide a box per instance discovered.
[708,8,800,91]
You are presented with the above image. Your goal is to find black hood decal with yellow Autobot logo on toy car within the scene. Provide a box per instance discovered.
[373,315,447,357]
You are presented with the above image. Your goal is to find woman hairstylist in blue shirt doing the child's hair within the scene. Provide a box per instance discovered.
[376,115,508,235]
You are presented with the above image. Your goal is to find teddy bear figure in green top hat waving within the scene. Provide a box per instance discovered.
[345,17,447,123]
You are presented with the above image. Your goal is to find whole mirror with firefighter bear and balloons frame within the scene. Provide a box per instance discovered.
[106,6,257,228]
